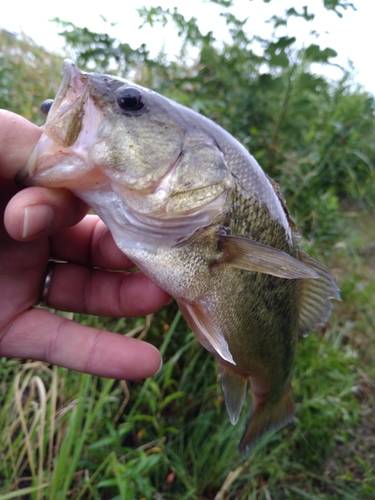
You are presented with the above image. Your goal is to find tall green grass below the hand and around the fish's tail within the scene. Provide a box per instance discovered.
[0,212,375,500]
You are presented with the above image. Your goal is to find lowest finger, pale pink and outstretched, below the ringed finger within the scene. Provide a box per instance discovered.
[0,309,161,380]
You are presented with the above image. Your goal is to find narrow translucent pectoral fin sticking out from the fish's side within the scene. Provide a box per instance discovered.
[217,236,319,279]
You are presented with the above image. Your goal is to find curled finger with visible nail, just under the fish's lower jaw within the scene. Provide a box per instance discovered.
[4,187,88,241]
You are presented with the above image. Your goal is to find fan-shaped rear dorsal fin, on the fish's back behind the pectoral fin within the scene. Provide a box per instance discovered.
[298,252,341,335]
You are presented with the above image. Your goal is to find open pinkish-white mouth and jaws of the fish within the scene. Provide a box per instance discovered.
[17,60,106,191]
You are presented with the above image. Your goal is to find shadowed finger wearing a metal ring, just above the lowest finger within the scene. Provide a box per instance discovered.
[47,264,171,317]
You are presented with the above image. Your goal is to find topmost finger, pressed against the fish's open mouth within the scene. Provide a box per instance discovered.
[0,109,42,180]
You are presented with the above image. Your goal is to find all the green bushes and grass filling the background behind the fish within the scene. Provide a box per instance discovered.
[0,0,375,500]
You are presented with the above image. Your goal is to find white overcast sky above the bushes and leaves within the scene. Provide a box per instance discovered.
[0,0,375,94]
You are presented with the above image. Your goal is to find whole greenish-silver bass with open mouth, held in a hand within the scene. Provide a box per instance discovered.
[18,60,340,455]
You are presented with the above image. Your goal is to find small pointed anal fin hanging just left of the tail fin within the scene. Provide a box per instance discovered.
[219,363,247,425]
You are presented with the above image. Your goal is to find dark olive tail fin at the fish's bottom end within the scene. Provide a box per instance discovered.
[238,382,294,455]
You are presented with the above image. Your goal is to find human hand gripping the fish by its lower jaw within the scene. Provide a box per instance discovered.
[0,110,170,379]
